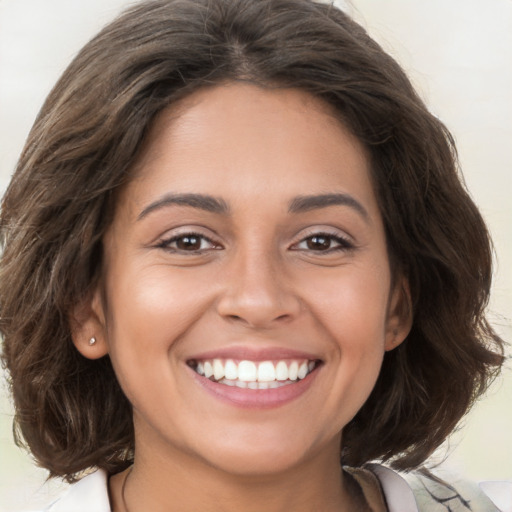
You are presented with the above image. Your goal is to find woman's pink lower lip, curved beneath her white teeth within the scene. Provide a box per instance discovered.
[189,367,319,409]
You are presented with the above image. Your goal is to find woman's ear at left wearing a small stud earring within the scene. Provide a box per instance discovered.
[69,285,108,359]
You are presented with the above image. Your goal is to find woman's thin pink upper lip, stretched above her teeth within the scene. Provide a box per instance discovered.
[188,346,321,361]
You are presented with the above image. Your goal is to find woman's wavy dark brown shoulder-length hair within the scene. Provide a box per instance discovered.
[0,0,503,481]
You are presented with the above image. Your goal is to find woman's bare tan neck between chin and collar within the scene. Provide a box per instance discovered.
[110,438,365,512]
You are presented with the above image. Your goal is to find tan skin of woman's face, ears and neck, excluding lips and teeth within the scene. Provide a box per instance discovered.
[74,83,410,512]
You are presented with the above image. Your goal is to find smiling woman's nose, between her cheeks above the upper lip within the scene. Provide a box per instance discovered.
[217,251,301,329]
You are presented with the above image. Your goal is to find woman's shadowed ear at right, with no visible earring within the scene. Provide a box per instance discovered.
[384,277,413,351]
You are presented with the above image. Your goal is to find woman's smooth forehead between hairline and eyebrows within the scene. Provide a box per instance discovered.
[118,83,375,219]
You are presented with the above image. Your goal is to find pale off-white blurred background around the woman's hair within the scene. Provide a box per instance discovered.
[0,0,512,511]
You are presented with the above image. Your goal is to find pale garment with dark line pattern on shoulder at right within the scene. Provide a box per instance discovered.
[369,464,512,512]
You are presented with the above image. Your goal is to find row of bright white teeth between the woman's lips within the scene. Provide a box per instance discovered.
[187,358,321,390]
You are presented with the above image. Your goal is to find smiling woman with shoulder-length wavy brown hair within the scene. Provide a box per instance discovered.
[0,0,503,511]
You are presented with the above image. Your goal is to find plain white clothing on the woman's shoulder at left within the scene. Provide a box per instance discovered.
[42,470,111,512]
